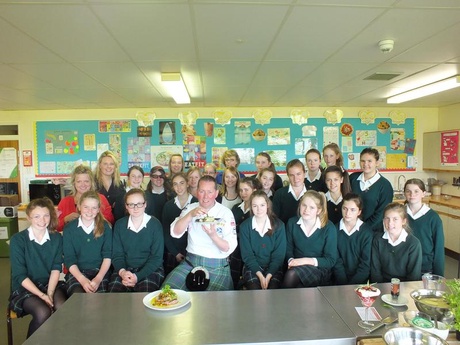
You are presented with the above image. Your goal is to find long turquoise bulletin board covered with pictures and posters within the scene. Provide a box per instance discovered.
[34,118,416,177]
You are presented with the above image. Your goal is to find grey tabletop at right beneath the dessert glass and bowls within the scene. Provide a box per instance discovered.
[318,281,423,338]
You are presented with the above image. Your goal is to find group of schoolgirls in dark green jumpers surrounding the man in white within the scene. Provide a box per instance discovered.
[10,144,444,336]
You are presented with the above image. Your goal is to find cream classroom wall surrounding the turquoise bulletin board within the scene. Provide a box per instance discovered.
[0,107,438,202]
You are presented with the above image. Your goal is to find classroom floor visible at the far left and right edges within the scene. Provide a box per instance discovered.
[0,256,458,344]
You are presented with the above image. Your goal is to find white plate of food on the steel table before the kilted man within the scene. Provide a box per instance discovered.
[142,285,191,311]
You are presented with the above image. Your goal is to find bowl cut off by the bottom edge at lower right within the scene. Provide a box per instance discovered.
[383,327,447,345]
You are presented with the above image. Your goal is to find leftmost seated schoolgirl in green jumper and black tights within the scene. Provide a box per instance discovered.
[9,198,67,338]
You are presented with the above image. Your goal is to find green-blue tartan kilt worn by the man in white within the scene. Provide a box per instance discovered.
[163,253,233,291]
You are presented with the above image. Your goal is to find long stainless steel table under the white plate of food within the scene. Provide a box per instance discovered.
[25,288,356,345]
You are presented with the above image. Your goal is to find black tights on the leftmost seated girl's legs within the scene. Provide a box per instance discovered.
[22,288,66,338]
